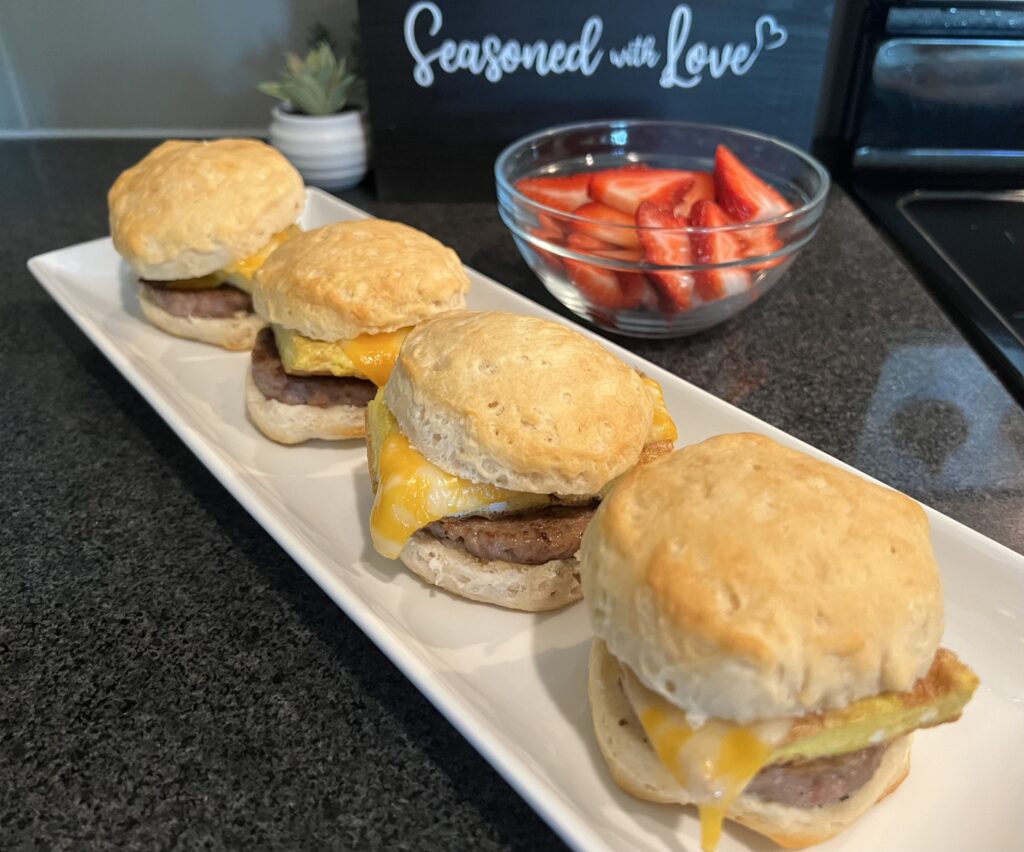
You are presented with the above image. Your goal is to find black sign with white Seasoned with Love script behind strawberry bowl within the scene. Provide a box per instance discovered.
[359,0,833,200]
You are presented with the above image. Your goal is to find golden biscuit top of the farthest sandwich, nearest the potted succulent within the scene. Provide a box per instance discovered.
[106,139,305,281]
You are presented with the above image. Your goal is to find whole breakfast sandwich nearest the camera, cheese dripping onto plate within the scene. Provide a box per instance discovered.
[581,434,978,850]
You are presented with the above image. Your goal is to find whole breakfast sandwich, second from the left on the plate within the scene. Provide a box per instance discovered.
[246,219,469,443]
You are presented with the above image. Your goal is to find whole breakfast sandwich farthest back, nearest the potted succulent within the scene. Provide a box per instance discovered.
[108,139,306,349]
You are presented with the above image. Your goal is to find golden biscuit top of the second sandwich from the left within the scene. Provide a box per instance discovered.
[253,219,469,340]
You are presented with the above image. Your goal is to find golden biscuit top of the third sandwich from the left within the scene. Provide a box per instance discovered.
[385,311,653,495]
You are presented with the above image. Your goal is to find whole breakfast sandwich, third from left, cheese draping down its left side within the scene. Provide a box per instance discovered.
[367,311,676,610]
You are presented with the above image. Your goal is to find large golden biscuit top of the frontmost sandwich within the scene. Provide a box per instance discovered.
[581,434,943,722]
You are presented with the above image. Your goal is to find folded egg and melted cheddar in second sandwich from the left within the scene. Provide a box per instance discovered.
[273,326,410,387]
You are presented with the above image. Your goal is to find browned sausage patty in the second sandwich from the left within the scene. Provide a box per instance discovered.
[253,329,377,409]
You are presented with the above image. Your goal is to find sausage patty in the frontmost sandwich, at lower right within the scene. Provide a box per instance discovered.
[743,746,888,808]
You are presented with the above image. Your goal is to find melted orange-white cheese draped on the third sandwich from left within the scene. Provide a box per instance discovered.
[367,391,551,559]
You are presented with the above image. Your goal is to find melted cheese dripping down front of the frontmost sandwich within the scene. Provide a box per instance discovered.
[623,667,790,852]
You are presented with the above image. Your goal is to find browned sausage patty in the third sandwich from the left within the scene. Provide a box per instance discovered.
[426,505,597,565]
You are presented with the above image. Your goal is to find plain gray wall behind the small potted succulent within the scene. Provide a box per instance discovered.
[0,0,355,136]
